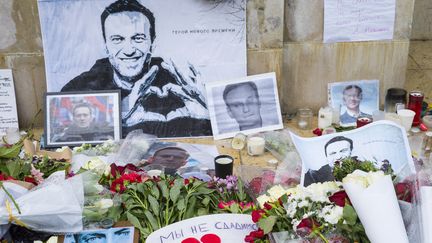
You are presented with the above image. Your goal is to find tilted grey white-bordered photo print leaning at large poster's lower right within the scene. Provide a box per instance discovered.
[206,73,283,139]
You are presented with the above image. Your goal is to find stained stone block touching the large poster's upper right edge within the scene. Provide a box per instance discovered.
[246,0,284,49]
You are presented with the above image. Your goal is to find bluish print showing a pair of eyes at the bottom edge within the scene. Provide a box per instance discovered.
[64,227,134,243]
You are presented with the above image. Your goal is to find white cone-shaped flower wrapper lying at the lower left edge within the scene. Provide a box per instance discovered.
[0,172,84,233]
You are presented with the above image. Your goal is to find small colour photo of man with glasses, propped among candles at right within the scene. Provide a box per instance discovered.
[328,80,379,126]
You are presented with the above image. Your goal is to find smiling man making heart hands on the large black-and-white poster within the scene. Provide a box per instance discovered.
[61,0,211,137]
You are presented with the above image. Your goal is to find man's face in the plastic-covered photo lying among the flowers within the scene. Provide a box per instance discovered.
[152,148,189,169]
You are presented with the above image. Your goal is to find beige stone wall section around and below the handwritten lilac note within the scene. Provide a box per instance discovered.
[282,0,414,113]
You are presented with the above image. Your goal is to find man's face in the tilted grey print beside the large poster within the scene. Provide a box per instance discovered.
[225,85,261,127]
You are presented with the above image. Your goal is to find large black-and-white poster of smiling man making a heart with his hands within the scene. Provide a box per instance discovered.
[38,0,246,137]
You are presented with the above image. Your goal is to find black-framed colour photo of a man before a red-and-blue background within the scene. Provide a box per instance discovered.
[45,91,121,147]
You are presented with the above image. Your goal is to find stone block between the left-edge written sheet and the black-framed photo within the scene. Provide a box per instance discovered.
[0,55,46,128]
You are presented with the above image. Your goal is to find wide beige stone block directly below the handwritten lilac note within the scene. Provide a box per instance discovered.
[281,41,409,113]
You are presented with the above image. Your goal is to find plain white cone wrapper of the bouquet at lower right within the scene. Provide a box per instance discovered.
[343,170,409,243]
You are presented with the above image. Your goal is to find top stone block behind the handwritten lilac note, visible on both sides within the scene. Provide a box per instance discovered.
[284,0,416,42]
